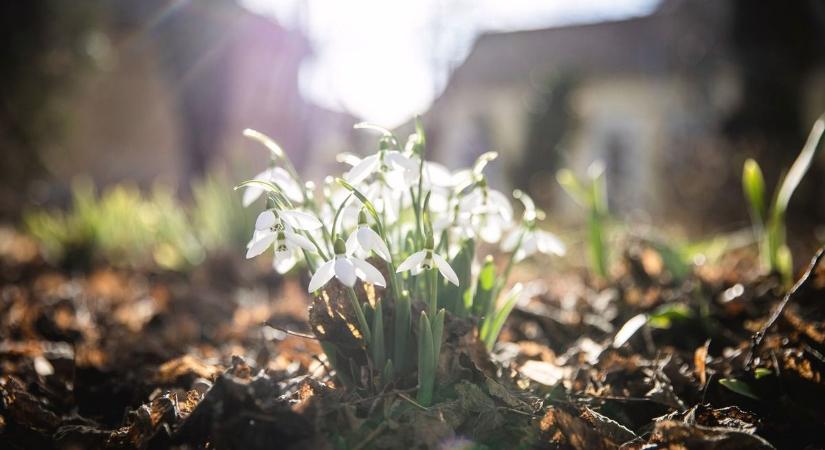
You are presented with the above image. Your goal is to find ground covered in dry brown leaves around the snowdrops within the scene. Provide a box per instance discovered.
[0,229,825,449]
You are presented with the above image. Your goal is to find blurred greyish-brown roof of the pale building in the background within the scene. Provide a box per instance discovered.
[438,0,724,94]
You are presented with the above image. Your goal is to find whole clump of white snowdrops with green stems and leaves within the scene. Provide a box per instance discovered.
[239,124,565,405]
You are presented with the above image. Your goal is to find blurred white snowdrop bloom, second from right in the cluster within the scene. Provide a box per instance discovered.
[459,183,513,243]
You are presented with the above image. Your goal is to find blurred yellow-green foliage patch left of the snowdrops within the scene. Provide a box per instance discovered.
[23,173,253,271]
